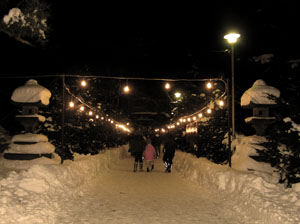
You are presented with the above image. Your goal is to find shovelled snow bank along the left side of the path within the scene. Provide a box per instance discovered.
[0,147,125,224]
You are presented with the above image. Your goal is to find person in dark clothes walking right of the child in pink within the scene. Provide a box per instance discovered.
[163,134,176,173]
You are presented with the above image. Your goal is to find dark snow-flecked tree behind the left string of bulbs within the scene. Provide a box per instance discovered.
[39,78,127,159]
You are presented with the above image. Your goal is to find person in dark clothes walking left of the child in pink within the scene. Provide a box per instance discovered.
[130,134,146,172]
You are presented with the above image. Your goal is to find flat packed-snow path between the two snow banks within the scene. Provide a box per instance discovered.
[57,158,256,224]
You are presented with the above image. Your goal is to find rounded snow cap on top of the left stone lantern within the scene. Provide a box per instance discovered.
[11,79,51,105]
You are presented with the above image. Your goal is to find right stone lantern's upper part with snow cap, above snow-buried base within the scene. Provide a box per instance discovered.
[241,79,280,136]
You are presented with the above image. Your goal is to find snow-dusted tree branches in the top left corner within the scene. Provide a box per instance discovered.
[0,0,49,46]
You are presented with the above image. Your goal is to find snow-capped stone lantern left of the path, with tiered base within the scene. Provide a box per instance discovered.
[4,79,55,160]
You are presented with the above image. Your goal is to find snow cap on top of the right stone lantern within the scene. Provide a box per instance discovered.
[241,79,280,107]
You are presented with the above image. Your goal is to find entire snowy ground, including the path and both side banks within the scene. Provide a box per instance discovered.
[0,147,300,224]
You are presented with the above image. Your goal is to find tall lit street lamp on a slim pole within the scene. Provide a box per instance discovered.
[224,33,240,139]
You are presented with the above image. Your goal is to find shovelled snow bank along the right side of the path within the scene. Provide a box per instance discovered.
[174,152,300,223]
